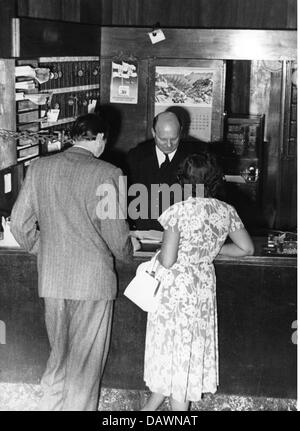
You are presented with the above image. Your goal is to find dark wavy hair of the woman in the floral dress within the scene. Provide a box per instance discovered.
[178,152,224,199]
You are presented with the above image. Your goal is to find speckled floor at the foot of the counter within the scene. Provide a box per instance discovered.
[0,383,297,411]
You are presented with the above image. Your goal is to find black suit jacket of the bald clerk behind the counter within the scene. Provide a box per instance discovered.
[126,140,207,230]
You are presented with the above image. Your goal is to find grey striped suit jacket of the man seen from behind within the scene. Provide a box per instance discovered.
[11,147,132,300]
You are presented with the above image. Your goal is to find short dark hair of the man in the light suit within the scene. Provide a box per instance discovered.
[71,114,108,139]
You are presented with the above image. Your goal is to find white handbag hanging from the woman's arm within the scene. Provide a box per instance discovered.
[124,252,160,313]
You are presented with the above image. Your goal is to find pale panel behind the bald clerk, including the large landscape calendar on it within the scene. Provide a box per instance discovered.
[150,60,225,142]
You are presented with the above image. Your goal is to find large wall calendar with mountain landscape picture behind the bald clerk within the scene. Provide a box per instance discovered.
[154,66,214,142]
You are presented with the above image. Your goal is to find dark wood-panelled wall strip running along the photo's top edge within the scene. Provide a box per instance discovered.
[10,0,297,29]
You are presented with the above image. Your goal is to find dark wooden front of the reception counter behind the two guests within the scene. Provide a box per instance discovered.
[0,241,297,398]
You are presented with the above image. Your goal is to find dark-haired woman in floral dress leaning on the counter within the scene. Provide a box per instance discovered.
[142,153,254,411]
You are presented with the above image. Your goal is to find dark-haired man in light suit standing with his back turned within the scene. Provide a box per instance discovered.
[11,114,132,411]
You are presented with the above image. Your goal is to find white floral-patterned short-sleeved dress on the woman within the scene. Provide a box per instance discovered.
[144,198,244,402]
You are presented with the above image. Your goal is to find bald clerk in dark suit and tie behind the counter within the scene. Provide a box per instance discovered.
[126,111,206,230]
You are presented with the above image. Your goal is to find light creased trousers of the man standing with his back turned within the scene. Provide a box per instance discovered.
[39,298,113,411]
